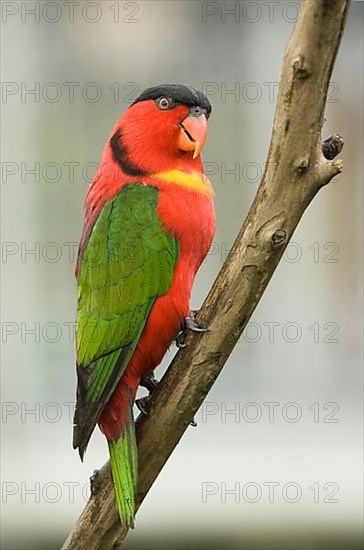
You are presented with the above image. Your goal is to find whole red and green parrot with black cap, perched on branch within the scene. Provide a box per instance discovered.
[73,84,216,528]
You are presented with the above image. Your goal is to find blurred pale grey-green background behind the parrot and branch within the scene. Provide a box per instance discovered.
[1,0,363,550]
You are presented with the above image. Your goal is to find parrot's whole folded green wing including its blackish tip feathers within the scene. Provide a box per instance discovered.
[73,184,179,458]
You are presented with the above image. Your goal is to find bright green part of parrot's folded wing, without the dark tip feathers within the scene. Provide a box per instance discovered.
[77,185,178,366]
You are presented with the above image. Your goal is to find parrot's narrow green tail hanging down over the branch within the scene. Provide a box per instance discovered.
[108,394,138,528]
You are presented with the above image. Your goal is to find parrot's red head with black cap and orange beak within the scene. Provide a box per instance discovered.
[109,84,211,177]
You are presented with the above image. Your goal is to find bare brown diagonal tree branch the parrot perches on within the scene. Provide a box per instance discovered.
[63,0,349,550]
